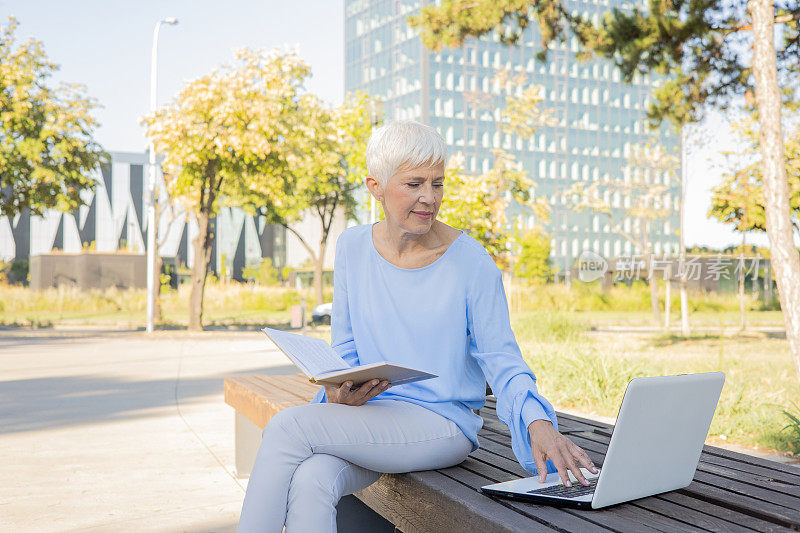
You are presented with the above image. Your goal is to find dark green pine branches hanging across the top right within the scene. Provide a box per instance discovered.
[409,0,800,125]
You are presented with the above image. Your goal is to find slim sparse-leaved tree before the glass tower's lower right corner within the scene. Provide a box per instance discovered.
[565,144,677,324]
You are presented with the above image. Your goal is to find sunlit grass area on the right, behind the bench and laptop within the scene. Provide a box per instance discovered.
[512,313,800,453]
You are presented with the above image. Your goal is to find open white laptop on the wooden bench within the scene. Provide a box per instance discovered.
[481,372,725,509]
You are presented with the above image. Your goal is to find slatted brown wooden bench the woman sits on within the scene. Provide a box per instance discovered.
[225,375,800,533]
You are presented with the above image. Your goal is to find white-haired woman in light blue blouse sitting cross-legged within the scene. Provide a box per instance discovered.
[239,121,596,533]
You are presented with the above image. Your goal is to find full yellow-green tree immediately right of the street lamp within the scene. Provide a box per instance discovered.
[143,49,309,330]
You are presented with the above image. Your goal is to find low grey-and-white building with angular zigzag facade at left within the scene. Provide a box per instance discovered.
[0,152,344,284]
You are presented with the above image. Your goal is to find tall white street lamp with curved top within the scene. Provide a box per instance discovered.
[147,17,178,333]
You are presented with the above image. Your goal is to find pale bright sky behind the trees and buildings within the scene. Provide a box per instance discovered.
[0,0,767,248]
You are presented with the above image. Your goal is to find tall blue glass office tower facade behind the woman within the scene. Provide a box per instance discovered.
[345,0,680,269]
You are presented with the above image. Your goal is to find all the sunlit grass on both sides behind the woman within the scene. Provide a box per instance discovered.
[0,283,800,453]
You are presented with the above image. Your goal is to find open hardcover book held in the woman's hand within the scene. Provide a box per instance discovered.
[261,328,438,387]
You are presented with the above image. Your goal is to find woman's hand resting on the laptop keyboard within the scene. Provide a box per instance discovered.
[528,420,597,487]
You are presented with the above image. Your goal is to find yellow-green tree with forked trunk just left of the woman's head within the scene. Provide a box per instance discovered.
[261,92,372,304]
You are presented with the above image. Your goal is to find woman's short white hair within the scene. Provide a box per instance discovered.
[367,120,447,187]
